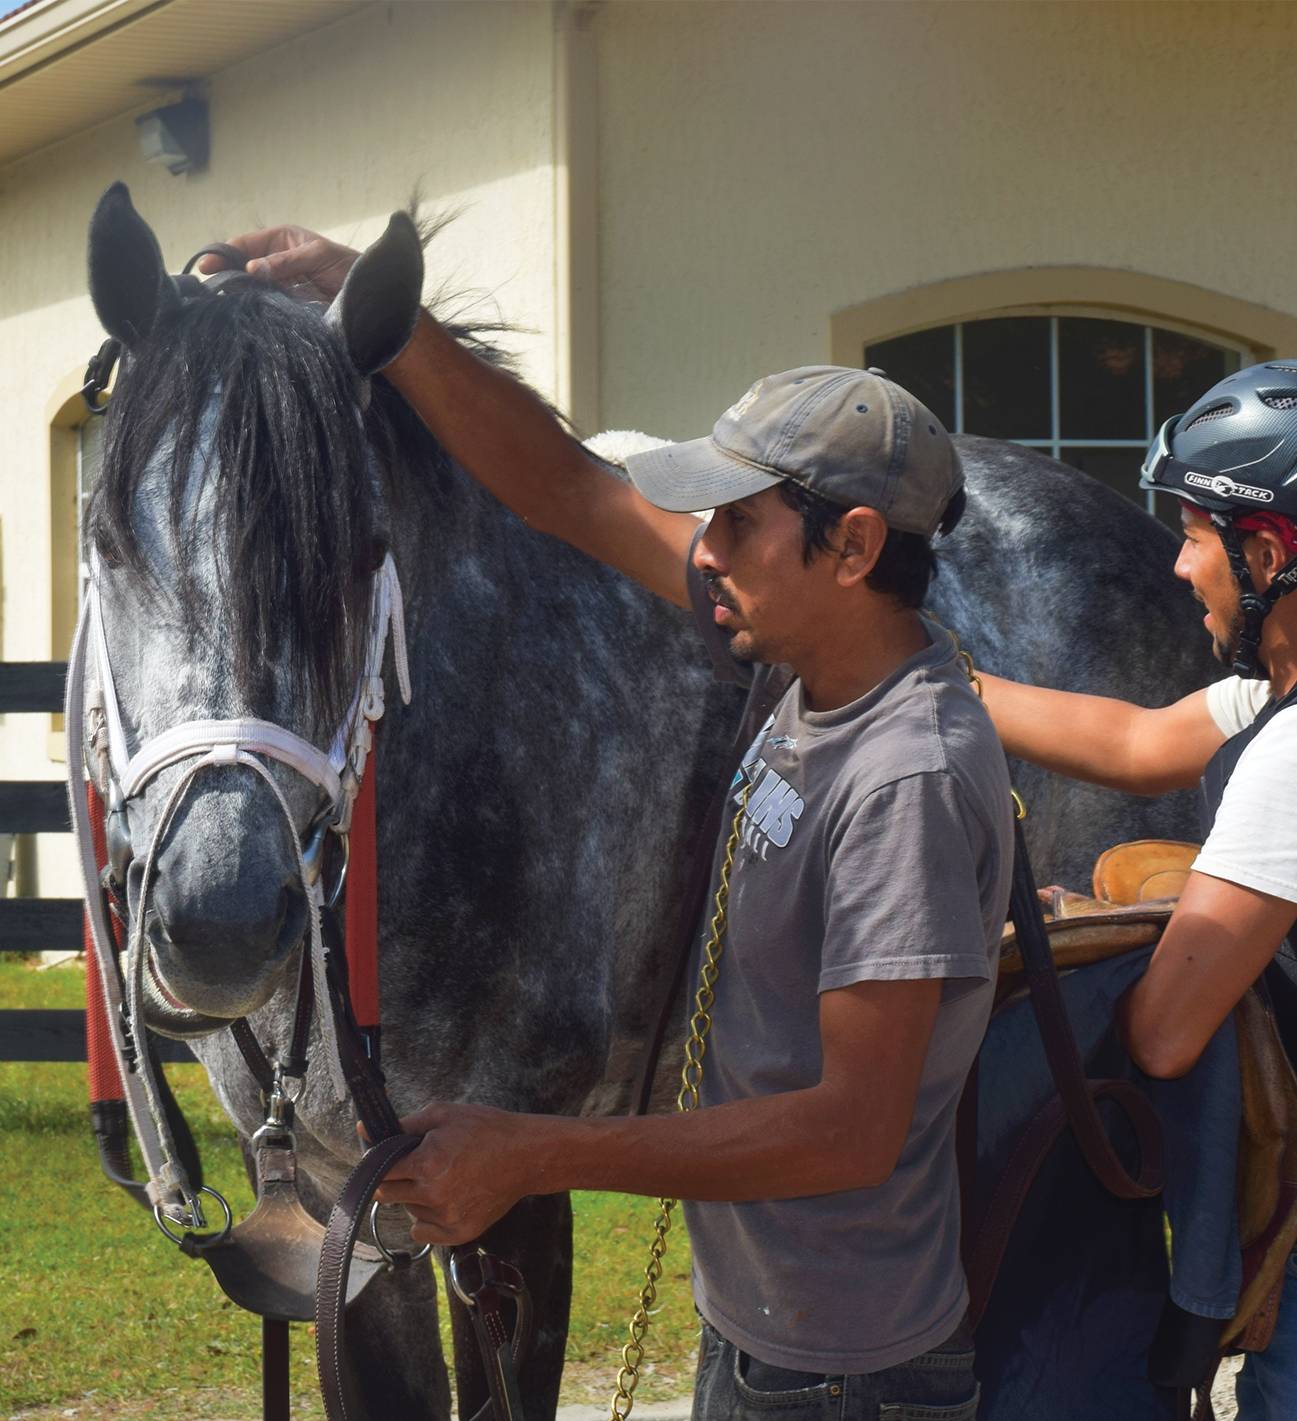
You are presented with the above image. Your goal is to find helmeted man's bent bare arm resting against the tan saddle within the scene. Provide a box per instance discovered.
[1122,872,1297,1077]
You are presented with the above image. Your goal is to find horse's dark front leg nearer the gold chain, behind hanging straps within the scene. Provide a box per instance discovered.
[446,1194,572,1421]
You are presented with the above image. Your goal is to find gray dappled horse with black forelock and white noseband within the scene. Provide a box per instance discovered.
[91,189,1210,1417]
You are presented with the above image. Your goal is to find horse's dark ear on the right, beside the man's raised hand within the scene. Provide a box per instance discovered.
[327,212,423,375]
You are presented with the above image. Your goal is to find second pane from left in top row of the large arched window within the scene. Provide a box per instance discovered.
[963,315,1051,439]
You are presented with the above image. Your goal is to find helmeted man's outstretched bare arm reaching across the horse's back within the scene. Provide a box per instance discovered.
[980,672,1225,794]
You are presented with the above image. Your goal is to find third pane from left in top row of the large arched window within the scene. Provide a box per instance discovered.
[1058,315,1148,439]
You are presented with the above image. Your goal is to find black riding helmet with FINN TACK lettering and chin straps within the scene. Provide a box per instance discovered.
[1139,360,1297,679]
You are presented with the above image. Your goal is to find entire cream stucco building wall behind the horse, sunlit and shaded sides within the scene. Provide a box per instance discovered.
[0,0,1297,892]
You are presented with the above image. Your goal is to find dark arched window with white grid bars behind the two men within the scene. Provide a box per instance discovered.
[864,314,1253,527]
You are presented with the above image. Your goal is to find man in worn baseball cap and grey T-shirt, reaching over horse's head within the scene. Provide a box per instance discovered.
[204,229,1013,1421]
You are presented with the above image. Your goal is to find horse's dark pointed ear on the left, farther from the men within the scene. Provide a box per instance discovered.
[89,182,176,350]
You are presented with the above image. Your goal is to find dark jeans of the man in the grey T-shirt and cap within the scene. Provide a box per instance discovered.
[693,1319,977,1421]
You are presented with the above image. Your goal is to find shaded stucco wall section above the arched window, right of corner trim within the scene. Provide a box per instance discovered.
[597,0,1297,436]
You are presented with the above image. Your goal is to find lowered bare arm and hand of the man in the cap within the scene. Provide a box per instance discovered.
[379,980,940,1243]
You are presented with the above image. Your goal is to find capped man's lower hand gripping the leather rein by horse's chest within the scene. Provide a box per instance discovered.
[378,1103,536,1245]
